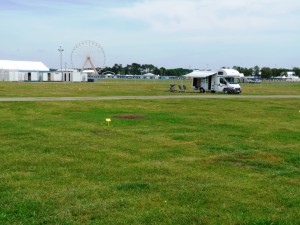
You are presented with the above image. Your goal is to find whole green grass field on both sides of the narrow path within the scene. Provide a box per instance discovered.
[0,81,300,225]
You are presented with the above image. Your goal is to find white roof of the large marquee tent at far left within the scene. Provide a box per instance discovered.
[0,60,49,71]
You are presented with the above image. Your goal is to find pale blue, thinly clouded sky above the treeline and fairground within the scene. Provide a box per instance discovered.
[0,0,300,69]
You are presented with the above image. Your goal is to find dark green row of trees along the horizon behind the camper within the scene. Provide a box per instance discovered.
[97,63,300,79]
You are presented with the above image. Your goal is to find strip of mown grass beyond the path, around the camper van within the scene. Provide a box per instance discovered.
[0,79,300,98]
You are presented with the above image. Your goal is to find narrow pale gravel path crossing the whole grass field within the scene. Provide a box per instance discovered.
[0,94,300,102]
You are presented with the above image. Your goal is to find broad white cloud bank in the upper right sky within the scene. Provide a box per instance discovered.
[113,0,300,32]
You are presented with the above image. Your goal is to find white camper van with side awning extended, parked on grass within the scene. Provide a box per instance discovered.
[185,69,243,94]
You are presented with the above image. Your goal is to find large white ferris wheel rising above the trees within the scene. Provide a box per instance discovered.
[71,40,106,74]
